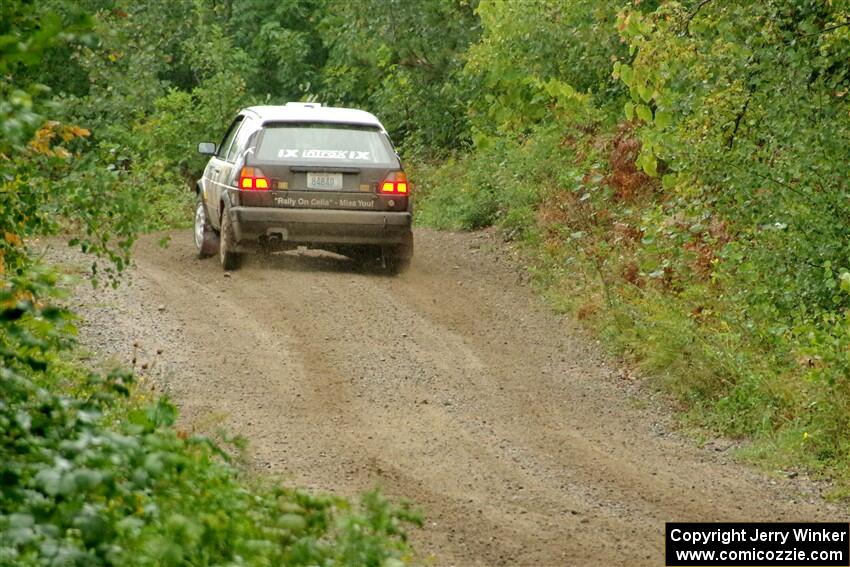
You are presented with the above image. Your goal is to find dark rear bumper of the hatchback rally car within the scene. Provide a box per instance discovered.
[225,207,413,246]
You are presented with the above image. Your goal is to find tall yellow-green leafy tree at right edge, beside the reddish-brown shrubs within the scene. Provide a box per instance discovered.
[614,0,850,461]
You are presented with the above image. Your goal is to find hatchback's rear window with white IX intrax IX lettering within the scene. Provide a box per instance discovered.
[256,123,398,167]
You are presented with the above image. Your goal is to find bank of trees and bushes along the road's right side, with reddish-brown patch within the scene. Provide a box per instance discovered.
[416,0,850,494]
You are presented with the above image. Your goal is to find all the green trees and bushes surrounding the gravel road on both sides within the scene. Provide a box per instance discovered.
[0,0,850,565]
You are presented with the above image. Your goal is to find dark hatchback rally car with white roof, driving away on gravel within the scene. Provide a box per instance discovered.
[195,103,413,273]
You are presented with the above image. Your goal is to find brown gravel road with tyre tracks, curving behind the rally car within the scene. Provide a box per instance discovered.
[56,230,846,566]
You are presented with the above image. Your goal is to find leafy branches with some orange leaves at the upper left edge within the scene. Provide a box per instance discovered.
[0,2,138,282]
